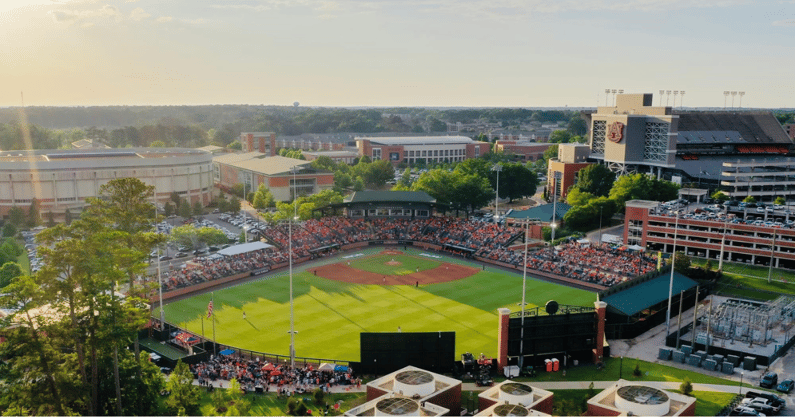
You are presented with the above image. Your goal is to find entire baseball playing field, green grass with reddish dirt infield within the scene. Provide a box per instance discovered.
[165,248,596,361]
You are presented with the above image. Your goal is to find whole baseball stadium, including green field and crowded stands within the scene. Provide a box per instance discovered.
[148,192,687,376]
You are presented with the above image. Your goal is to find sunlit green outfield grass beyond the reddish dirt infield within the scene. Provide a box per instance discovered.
[165,250,595,361]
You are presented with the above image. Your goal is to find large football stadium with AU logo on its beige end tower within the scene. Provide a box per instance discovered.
[586,94,795,201]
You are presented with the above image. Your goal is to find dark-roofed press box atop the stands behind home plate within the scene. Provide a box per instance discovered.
[313,191,448,219]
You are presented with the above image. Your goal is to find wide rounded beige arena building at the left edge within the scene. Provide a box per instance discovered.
[0,148,213,221]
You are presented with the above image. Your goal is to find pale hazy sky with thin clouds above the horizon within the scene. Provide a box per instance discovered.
[0,0,795,108]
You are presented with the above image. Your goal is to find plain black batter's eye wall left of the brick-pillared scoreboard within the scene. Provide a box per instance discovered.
[357,332,455,375]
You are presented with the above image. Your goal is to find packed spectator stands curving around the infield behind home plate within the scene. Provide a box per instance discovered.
[157,217,655,291]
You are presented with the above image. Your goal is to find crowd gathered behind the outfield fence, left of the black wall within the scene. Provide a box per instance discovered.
[190,356,360,395]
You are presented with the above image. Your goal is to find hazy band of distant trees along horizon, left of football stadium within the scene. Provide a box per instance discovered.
[0,105,592,150]
